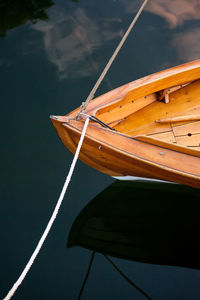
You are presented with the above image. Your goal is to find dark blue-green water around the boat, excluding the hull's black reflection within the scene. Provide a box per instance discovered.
[0,0,200,300]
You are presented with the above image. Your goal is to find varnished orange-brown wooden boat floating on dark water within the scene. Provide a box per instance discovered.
[51,60,200,188]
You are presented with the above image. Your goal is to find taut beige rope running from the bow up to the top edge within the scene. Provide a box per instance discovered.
[79,0,148,115]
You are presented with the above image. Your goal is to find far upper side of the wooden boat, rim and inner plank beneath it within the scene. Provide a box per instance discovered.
[68,60,200,122]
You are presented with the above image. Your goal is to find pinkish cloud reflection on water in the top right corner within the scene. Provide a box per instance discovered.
[146,0,200,64]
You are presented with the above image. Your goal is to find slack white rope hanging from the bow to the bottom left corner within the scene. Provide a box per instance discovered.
[3,118,89,300]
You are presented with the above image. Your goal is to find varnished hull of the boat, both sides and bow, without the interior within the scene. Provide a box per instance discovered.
[52,61,200,188]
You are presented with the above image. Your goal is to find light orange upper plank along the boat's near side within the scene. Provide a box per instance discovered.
[67,120,200,176]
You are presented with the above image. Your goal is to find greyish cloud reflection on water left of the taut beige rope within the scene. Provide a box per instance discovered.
[33,8,122,79]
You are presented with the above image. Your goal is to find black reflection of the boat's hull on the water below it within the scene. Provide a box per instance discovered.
[67,181,200,269]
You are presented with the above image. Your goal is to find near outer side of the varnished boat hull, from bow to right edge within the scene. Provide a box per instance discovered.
[52,114,200,187]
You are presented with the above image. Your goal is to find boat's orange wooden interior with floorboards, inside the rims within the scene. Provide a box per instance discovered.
[95,80,200,151]
